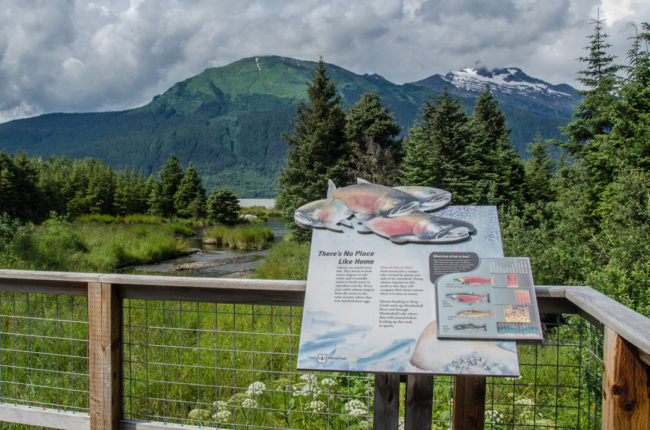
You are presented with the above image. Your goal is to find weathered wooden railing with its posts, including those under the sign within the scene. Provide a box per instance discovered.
[0,270,650,430]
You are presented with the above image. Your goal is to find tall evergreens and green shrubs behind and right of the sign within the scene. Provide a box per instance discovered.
[277,20,650,315]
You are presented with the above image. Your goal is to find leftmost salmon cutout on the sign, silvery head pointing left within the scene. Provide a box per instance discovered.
[293,199,352,231]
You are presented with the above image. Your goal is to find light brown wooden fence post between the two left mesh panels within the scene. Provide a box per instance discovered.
[88,282,122,430]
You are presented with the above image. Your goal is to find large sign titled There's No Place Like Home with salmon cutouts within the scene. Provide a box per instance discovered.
[295,180,519,376]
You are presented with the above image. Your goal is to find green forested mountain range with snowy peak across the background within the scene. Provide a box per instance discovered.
[0,56,575,197]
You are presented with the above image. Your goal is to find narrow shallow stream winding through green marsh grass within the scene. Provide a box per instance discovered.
[122,218,288,278]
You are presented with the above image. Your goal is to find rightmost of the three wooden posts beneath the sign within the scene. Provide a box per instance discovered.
[451,375,486,430]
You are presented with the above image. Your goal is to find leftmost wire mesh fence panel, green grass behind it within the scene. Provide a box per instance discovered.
[0,292,88,412]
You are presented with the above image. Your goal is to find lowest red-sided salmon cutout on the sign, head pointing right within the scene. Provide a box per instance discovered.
[364,212,474,243]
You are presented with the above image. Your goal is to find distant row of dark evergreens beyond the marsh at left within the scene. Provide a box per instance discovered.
[0,152,239,223]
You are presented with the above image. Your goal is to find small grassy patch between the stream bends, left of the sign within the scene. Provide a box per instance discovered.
[204,224,273,249]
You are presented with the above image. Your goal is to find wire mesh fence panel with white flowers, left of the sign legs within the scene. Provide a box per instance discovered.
[124,300,374,429]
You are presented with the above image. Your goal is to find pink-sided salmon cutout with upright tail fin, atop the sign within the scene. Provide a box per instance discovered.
[327,180,420,221]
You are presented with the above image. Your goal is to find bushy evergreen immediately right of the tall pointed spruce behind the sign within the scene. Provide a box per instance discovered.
[345,93,402,185]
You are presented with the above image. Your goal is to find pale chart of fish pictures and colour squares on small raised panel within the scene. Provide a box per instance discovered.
[436,258,543,341]
